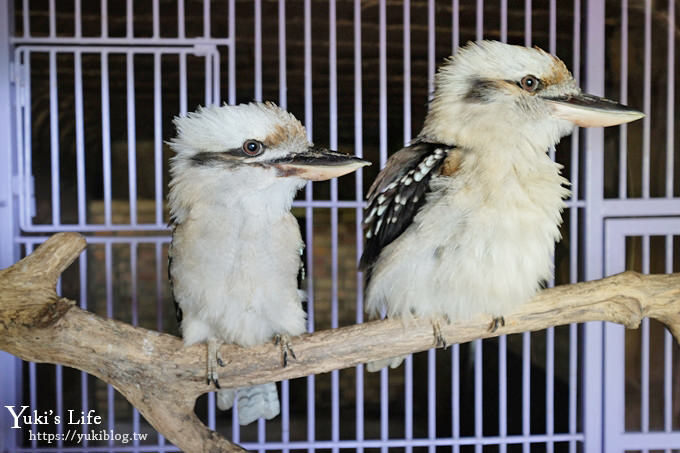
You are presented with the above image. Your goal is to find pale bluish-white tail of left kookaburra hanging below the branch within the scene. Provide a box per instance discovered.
[217,382,281,425]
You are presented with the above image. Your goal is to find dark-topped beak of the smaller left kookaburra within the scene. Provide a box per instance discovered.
[270,147,371,181]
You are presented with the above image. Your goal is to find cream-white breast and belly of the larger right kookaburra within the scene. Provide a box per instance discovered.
[367,150,569,319]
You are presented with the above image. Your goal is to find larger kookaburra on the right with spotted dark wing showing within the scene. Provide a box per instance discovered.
[360,41,644,370]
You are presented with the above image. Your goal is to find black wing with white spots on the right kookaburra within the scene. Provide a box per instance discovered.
[359,142,453,270]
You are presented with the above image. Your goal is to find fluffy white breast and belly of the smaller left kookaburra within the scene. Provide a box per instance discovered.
[172,210,305,346]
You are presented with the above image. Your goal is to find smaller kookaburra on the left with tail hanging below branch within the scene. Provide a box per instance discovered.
[168,103,368,425]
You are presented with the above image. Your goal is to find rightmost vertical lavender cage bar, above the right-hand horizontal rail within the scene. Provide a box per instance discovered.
[666,0,675,198]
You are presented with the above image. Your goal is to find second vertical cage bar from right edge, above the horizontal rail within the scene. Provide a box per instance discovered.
[642,0,652,198]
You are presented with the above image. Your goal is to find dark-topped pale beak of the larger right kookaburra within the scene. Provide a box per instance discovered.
[547,93,645,127]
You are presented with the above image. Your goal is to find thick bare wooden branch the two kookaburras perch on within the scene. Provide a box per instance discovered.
[0,233,680,452]
